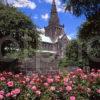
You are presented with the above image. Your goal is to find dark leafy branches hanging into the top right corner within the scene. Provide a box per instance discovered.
[63,0,100,18]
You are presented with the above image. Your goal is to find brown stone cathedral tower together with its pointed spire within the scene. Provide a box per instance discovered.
[45,0,64,40]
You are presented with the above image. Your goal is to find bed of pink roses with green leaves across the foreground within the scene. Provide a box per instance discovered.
[0,69,100,100]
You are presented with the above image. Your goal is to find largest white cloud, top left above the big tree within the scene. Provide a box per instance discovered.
[8,0,36,9]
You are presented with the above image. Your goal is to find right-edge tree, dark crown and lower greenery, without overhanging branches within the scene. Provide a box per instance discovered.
[78,12,100,66]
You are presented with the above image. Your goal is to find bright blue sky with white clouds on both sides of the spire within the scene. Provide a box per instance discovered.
[8,0,85,38]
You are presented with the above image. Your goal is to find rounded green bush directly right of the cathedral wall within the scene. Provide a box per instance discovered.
[59,40,88,67]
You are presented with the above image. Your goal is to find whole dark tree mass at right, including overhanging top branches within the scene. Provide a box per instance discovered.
[64,0,100,68]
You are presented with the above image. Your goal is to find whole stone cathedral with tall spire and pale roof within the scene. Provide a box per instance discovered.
[20,0,69,74]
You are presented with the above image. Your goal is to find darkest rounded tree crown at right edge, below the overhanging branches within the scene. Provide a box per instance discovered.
[78,12,100,41]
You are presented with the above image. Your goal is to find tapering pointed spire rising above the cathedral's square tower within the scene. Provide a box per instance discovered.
[49,0,59,26]
